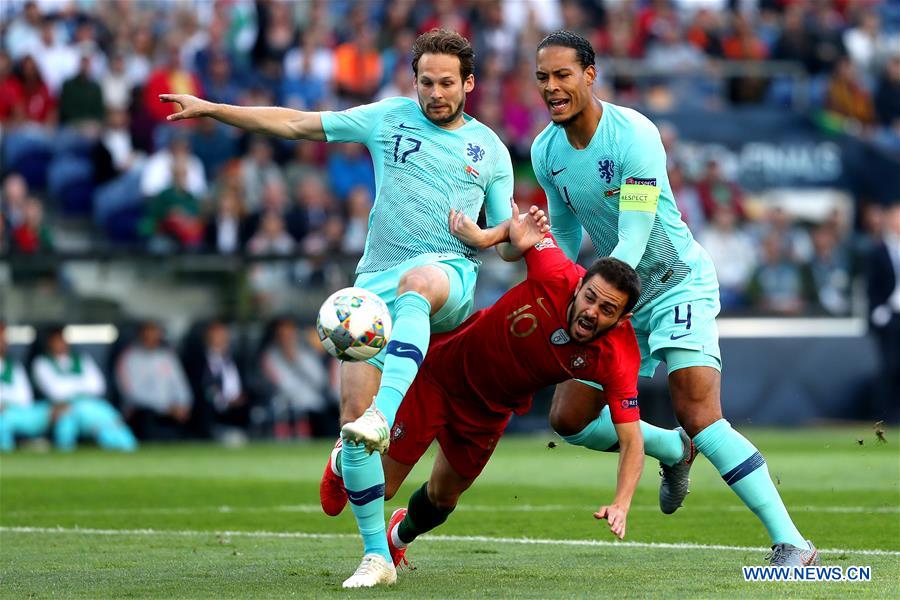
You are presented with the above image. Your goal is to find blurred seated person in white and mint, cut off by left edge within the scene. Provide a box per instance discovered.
[0,322,50,452]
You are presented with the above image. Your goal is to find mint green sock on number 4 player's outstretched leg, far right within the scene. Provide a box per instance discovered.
[694,419,807,548]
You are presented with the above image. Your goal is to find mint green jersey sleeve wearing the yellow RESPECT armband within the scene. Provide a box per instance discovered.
[610,121,666,267]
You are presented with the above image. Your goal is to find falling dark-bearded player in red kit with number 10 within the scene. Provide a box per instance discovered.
[323,205,644,564]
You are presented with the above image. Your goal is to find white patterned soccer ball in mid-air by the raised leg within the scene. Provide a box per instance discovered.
[316,287,391,361]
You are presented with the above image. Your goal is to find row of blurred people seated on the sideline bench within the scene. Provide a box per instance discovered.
[0,317,339,451]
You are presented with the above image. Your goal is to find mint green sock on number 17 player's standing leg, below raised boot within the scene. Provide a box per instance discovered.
[341,444,391,562]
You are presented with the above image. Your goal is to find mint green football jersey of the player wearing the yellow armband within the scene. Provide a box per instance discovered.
[531,102,704,311]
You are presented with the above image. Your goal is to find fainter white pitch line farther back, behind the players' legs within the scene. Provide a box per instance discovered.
[4,504,900,516]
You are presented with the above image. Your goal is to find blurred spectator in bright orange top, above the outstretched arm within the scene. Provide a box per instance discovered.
[334,26,383,103]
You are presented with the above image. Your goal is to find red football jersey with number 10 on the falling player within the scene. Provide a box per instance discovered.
[423,235,641,423]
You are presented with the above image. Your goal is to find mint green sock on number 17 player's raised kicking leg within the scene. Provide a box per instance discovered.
[375,292,431,426]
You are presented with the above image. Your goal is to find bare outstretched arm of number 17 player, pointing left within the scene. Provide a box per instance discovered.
[159,94,325,142]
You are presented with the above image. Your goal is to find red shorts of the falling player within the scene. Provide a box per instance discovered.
[388,370,512,479]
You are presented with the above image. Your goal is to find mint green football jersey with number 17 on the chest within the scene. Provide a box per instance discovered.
[322,98,513,273]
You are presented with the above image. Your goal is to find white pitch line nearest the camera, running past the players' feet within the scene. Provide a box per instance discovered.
[0,527,900,556]
